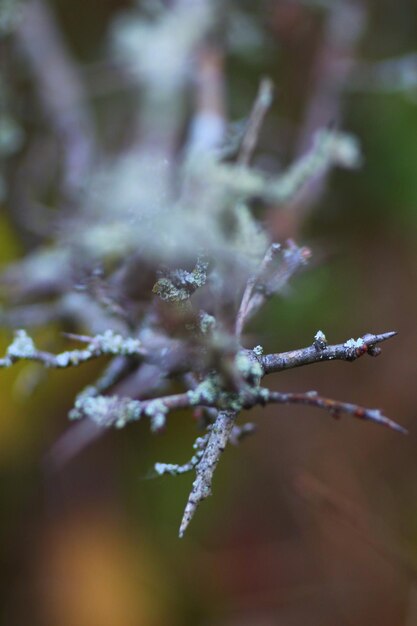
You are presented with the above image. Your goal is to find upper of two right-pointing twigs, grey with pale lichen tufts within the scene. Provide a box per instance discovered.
[261,331,397,374]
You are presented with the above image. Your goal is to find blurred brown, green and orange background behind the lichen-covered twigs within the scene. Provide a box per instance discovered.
[0,0,417,626]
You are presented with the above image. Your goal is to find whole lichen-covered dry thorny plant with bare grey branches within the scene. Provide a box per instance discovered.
[0,0,404,536]
